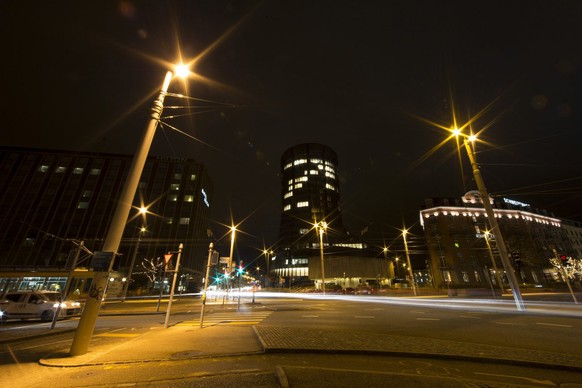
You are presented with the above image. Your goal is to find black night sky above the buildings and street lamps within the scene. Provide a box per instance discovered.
[0,0,582,258]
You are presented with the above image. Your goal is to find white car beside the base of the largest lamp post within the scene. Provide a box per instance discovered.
[0,291,81,321]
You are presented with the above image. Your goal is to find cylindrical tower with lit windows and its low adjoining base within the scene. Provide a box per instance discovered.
[271,143,389,288]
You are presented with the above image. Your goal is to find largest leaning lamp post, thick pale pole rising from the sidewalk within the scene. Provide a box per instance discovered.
[69,67,189,356]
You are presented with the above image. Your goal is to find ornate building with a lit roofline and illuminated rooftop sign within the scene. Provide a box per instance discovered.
[420,191,574,287]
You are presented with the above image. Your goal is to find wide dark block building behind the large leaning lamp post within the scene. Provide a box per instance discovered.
[0,148,212,292]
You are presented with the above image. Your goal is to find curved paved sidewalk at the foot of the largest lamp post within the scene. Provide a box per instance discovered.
[30,325,582,371]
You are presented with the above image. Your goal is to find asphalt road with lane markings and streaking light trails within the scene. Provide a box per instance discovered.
[0,297,582,387]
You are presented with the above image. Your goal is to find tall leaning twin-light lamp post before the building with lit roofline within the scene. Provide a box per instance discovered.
[464,136,525,311]
